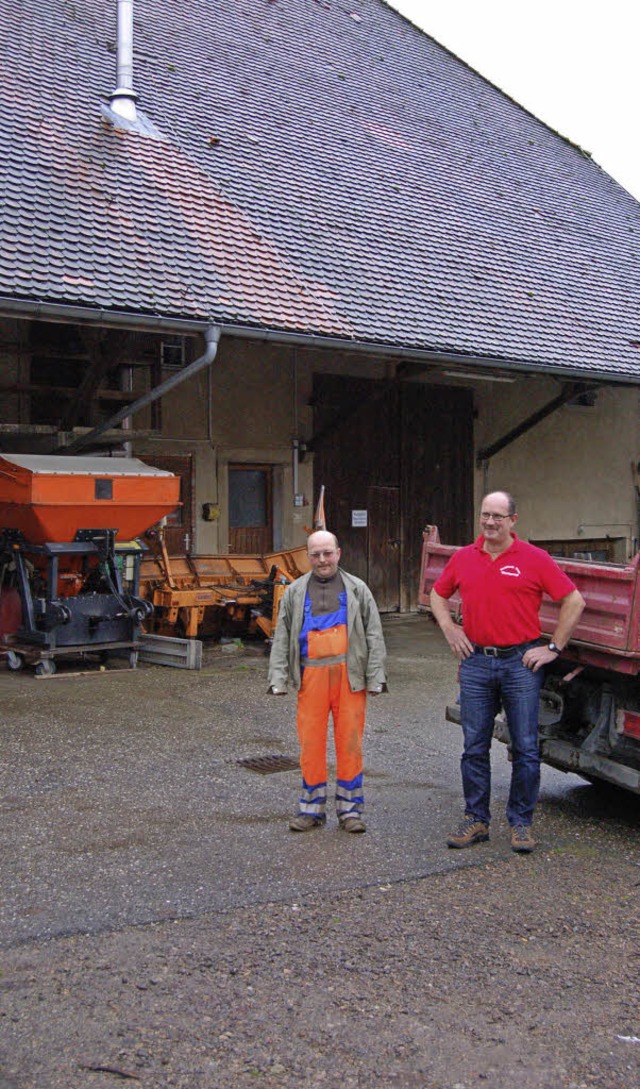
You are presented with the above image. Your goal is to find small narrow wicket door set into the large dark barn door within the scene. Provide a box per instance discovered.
[367,487,401,613]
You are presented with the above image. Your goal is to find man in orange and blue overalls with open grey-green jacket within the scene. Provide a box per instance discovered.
[268,530,386,832]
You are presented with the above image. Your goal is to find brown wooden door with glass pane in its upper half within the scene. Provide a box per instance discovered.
[229,465,273,555]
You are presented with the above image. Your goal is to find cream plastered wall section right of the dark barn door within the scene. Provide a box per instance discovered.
[476,378,640,560]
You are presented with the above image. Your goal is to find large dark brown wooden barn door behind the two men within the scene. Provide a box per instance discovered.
[312,375,473,612]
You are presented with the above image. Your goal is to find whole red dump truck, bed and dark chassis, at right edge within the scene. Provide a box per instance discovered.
[418,526,640,794]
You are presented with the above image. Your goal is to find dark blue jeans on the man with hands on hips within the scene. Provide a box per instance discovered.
[460,651,544,825]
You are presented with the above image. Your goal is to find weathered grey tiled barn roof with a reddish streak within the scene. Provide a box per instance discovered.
[0,0,640,381]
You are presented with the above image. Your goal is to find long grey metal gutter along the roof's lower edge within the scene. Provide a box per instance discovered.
[0,296,640,386]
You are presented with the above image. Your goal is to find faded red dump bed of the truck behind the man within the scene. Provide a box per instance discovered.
[418,526,640,674]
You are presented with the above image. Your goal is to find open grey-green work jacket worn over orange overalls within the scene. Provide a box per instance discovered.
[268,567,386,692]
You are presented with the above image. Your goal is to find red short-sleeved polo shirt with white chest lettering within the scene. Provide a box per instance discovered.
[433,534,576,647]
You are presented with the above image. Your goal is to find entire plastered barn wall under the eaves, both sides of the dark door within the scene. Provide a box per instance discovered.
[0,320,640,560]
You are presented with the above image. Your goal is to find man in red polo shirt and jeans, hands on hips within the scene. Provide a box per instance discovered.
[431,491,584,853]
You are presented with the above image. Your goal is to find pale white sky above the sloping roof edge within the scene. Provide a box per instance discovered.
[387,0,640,200]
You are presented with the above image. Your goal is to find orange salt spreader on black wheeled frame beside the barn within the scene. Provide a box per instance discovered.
[0,454,180,673]
